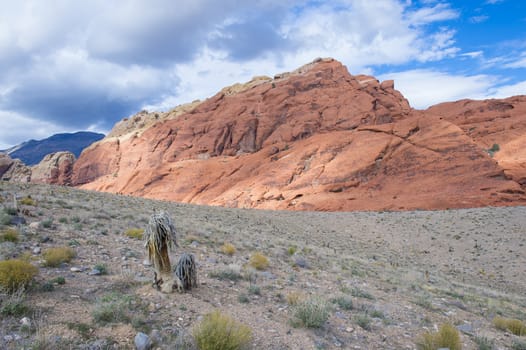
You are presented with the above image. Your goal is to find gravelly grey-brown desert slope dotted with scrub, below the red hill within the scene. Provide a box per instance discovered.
[0,183,526,349]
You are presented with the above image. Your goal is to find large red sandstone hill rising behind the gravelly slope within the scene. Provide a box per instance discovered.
[73,60,526,210]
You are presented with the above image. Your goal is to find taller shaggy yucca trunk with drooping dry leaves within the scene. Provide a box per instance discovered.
[144,212,182,293]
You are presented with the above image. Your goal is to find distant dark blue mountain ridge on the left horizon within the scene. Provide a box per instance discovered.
[1,131,104,166]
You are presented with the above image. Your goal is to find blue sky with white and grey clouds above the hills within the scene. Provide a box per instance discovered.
[0,0,526,149]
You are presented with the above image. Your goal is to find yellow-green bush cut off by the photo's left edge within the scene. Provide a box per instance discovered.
[0,259,38,292]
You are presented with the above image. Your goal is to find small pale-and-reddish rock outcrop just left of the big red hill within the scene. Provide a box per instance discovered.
[31,152,75,185]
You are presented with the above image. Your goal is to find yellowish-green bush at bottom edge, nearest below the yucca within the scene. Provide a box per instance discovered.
[192,310,252,350]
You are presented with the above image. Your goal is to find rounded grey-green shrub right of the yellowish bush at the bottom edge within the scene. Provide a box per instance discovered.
[292,296,330,328]
